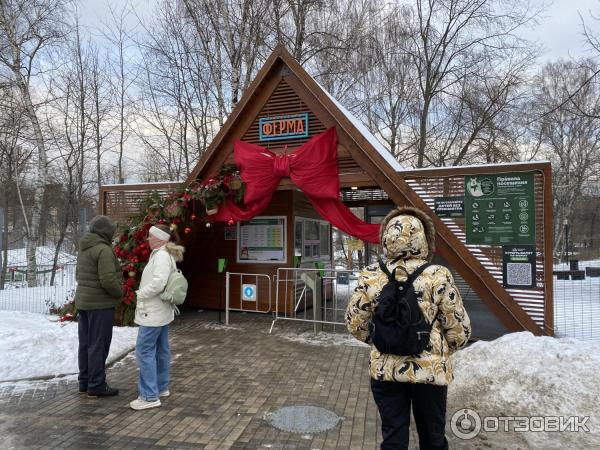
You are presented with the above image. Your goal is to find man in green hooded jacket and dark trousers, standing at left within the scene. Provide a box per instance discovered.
[75,216,123,397]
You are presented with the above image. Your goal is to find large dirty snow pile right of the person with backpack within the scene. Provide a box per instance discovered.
[448,332,600,448]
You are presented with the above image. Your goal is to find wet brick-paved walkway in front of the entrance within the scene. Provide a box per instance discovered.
[0,312,428,450]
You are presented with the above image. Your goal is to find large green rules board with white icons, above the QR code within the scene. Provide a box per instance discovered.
[465,172,535,245]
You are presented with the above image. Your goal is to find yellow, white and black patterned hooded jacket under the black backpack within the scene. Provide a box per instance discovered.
[346,207,471,385]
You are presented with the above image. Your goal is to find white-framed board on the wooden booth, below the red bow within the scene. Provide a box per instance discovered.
[237,216,286,263]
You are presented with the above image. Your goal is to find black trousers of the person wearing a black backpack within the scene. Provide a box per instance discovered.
[371,379,448,450]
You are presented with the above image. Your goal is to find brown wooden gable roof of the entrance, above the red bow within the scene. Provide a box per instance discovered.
[187,46,552,335]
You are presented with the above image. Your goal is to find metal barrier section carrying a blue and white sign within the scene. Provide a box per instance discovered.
[225,272,273,324]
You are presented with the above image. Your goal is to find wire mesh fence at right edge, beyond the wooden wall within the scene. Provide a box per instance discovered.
[554,260,600,342]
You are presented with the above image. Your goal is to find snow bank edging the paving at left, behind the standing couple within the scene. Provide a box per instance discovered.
[0,311,137,381]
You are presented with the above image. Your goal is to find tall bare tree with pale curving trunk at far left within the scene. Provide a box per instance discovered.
[0,0,65,286]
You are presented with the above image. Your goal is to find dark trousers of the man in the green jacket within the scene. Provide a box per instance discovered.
[77,308,115,391]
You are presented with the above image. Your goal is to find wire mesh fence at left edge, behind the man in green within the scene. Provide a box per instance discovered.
[0,264,75,314]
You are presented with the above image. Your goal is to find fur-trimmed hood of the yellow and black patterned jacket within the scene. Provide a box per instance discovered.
[379,206,435,261]
